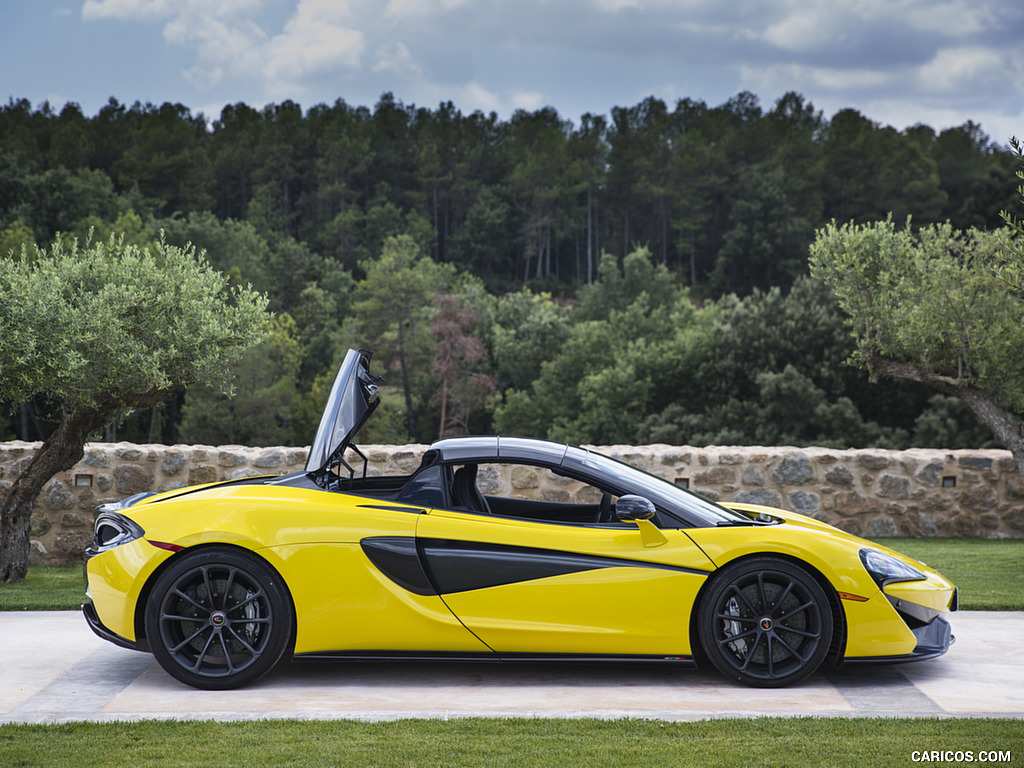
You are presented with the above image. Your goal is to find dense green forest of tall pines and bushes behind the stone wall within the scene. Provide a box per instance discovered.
[0,92,1017,449]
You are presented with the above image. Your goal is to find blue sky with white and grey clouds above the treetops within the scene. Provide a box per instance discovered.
[0,0,1024,144]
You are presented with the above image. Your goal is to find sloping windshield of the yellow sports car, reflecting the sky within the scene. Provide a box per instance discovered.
[562,449,750,525]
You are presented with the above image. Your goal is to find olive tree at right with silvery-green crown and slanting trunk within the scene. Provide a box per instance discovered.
[811,217,1024,475]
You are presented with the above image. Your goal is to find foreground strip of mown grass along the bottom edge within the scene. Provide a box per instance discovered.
[0,718,1024,768]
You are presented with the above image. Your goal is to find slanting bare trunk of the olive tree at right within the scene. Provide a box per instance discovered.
[861,349,1024,478]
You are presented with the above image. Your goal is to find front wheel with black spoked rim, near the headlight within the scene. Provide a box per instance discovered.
[697,557,835,688]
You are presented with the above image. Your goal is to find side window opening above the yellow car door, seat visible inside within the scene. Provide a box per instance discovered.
[452,463,617,524]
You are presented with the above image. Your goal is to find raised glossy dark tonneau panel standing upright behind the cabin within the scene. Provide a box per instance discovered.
[306,349,380,472]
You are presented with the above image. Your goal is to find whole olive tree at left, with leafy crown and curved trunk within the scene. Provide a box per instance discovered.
[0,236,267,582]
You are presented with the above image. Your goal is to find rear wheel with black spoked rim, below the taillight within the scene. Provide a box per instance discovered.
[145,549,292,690]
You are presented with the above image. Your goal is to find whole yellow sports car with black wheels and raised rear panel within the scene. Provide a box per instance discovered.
[83,350,956,688]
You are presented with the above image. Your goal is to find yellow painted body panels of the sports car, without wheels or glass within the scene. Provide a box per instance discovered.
[87,483,953,657]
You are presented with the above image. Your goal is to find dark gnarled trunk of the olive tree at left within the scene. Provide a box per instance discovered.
[0,411,105,582]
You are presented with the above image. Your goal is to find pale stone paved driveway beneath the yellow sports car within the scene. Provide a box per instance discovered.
[0,611,1024,723]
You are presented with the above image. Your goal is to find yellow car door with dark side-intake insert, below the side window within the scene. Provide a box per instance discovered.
[417,499,714,657]
